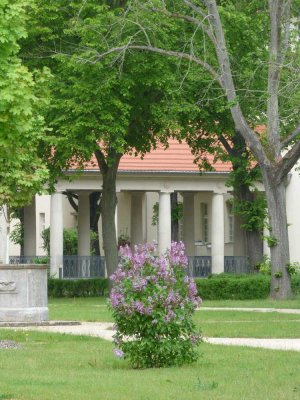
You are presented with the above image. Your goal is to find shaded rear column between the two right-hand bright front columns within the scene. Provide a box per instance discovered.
[182,193,195,256]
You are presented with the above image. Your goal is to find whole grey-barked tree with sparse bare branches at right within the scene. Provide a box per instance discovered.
[95,0,300,298]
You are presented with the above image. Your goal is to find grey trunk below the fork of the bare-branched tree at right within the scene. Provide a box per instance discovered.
[263,169,292,299]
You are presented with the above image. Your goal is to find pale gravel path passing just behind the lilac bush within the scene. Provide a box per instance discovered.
[6,322,300,351]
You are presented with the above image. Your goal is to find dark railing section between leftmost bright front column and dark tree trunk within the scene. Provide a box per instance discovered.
[60,256,105,278]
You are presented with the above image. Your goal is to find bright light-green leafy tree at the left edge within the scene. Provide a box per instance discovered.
[0,0,48,214]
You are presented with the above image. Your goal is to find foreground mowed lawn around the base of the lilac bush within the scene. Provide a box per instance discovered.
[0,330,300,400]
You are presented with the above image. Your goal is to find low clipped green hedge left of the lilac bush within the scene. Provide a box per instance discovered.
[48,278,108,297]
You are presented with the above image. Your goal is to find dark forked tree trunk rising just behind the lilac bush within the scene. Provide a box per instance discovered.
[95,149,122,291]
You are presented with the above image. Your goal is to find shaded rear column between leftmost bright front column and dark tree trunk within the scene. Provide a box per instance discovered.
[78,192,91,256]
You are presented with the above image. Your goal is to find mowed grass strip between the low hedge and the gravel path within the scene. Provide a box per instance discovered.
[49,297,300,338]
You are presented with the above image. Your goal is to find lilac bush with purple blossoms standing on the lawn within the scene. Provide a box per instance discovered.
[110,242,201,368]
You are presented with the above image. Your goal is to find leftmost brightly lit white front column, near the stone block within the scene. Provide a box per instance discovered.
[50,193,63,278]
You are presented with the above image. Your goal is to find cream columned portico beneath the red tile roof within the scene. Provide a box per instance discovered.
[45,171,233,276]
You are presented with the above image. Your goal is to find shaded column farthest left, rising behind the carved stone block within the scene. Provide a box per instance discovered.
[24,197,37,257]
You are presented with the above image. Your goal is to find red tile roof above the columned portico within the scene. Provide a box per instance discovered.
[85,139,231,172]
